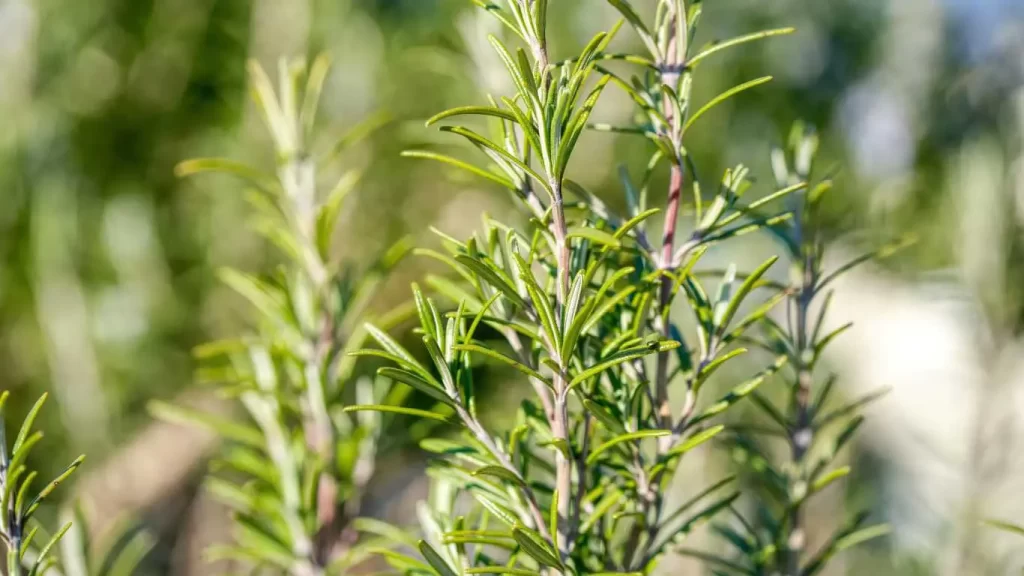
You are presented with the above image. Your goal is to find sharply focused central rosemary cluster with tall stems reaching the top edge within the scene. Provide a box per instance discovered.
[354,0,805,576]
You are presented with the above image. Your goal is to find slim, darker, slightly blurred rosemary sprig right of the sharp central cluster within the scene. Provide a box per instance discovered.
[710,124,901,576]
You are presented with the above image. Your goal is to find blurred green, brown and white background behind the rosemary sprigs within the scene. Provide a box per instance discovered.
[0,0,1024,575]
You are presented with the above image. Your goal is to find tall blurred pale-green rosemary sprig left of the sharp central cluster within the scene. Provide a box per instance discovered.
[153,57,411,576]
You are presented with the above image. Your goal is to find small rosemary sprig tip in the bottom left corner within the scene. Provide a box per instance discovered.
[0,392,85,576]
